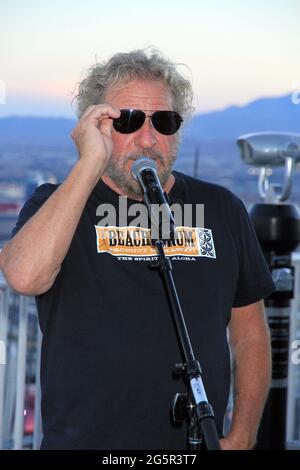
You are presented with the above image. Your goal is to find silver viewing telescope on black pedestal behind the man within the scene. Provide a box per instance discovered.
[237,132,300,449]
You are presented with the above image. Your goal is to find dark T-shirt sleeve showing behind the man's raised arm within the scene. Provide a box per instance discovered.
[11,183,58,238]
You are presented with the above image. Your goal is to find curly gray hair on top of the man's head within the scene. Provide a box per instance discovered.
[75,48,193,118]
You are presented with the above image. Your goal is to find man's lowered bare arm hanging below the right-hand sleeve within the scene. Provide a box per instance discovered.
[221,300,271,449]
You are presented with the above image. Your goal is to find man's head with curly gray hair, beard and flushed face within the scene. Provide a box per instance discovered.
[72,50,192,197]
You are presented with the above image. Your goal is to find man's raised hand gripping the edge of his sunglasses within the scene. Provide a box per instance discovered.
[71,104,121,172]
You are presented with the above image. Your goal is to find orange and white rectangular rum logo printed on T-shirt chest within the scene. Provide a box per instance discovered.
[95,225,216,259]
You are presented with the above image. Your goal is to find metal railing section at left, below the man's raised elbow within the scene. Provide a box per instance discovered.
[0,272,42,450]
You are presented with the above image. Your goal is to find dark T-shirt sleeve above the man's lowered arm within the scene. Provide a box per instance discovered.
[231,197,276,307]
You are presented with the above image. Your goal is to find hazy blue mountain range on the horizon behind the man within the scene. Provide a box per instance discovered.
[0,95,300,149]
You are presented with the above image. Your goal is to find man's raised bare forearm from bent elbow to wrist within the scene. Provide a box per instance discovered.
[0,159,101,295]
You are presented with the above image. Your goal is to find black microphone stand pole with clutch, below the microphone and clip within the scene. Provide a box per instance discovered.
[151,240,220,450]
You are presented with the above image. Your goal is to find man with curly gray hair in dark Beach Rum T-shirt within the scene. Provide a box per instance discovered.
[0,50,274,449]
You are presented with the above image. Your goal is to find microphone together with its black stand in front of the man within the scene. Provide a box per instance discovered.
[132,162,220,450]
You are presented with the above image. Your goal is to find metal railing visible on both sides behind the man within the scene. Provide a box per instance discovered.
[0,253,300,449]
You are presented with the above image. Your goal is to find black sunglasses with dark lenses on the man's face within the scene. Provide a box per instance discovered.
[113,109,183,135]
